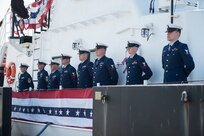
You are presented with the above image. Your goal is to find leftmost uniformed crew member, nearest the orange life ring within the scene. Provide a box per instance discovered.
[18,63,34,92]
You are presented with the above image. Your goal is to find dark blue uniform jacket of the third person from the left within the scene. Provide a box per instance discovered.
[48,70,60,89]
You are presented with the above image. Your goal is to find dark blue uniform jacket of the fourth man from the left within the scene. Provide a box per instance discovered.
[60,64,77,88]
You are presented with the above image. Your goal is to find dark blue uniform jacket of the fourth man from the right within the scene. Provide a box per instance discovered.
[77,60,93,88]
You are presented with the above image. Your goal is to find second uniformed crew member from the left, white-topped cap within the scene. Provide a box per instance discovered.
[37,61,48,90]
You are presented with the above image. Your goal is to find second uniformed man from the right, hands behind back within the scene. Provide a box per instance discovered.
[126,41,152,85]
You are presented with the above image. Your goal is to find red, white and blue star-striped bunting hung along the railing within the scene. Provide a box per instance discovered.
[12,89,93,128]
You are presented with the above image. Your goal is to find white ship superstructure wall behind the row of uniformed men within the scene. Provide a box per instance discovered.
[0,0,204,136]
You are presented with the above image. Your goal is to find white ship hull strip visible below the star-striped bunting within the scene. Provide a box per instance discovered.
[11,119,92,136]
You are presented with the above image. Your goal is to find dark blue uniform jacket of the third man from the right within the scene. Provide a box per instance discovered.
[93,56,118,86]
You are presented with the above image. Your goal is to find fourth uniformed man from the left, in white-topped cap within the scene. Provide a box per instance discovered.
[60,54,77,88]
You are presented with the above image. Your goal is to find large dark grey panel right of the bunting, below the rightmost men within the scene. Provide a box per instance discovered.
[93,84,204,136]
